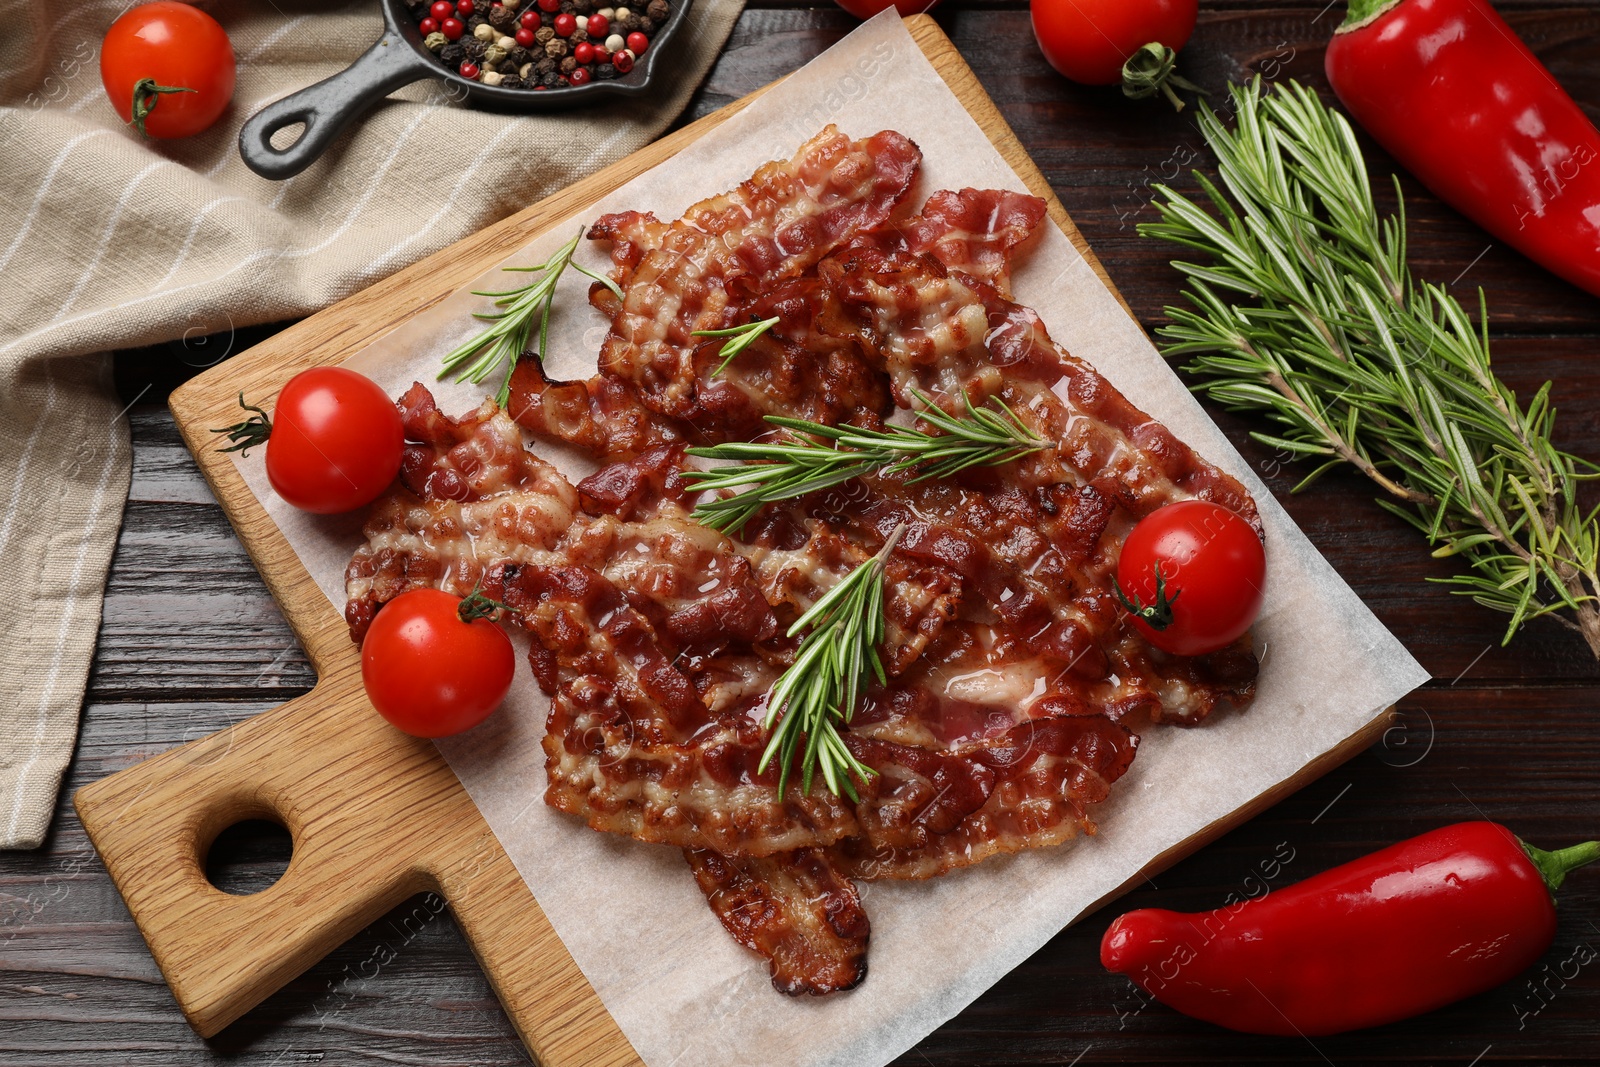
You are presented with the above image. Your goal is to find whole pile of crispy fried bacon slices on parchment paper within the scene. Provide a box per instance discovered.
[346,128,1256,993]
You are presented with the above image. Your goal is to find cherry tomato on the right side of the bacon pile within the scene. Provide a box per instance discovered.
[1117,501,1267,656]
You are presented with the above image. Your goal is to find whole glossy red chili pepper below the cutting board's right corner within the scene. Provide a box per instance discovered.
[1101,822,1600,1035]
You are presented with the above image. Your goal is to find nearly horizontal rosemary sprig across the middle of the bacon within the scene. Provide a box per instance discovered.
[683,392,1046,533]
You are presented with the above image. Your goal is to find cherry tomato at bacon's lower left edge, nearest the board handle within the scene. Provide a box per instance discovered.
[362,589,517,737]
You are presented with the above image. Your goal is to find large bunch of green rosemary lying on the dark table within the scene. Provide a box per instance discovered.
[1139,78,1600,656]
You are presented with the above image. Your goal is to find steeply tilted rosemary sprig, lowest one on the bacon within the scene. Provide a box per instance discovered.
[755,526,904,800]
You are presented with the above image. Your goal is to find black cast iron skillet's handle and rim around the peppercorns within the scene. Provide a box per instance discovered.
[238,0,690,179]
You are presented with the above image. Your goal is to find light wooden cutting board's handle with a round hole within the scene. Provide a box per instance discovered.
[74,678,438,1035]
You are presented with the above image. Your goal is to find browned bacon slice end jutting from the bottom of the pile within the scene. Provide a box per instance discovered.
[683,848,872,997]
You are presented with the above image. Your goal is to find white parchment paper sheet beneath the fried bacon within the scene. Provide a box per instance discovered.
[222,8,1427,1067]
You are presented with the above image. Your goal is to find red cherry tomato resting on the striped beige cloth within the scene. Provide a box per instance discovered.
[101,0,235,138]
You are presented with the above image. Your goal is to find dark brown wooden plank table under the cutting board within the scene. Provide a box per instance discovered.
[0,0,1600,1067]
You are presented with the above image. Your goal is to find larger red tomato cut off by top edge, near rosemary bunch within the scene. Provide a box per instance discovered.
[1029,0,1198,85]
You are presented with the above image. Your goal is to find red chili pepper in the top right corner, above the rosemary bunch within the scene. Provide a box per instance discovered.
[1326,0,1600,296]
